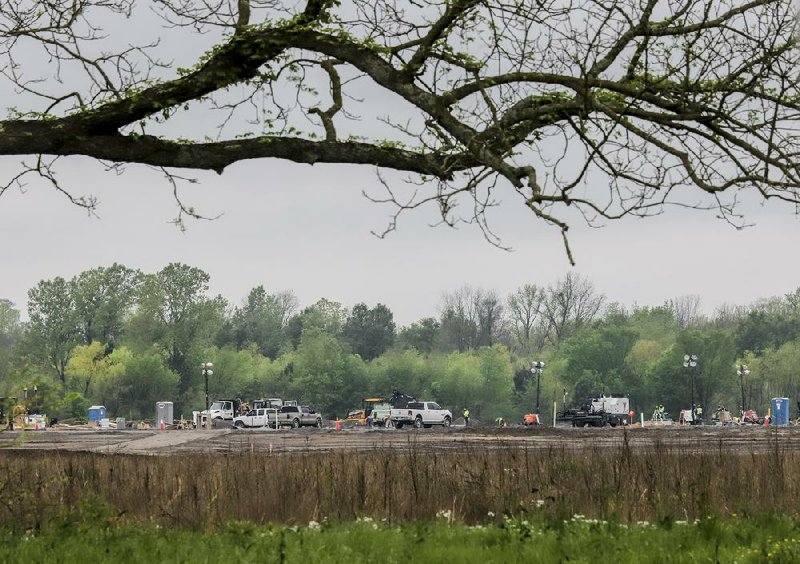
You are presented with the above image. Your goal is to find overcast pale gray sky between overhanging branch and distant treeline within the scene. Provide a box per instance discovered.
[0,2,800,325]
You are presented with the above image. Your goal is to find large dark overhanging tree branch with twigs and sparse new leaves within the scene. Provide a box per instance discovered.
[0,0,800,256]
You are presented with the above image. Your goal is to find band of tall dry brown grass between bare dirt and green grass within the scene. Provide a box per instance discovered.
[0,432,800,529]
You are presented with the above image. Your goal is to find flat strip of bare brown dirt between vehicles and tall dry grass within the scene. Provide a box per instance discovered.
[0,426,800,455]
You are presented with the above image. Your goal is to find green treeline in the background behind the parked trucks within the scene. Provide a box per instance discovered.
[0,263,800,421]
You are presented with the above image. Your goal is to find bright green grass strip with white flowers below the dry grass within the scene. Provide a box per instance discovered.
[0,515,800,564]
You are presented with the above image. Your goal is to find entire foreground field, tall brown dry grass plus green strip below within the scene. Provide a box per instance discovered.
[0,442,800,563]
